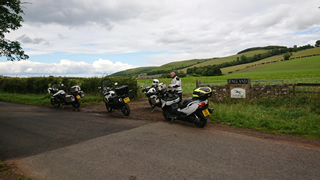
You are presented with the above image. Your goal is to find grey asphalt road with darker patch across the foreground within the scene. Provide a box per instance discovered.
[0,102,320,180]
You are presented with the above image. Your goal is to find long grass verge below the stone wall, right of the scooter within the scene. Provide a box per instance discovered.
[211,95,320,139]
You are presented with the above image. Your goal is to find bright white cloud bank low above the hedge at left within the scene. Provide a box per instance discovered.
[0,59,135,76]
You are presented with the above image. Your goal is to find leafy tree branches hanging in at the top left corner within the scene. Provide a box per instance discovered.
[0,0,29,61]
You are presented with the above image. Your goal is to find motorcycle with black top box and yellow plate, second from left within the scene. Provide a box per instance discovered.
[99,81,134,116]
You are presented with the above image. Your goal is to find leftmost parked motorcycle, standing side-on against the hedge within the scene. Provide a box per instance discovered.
[48,84,84,108]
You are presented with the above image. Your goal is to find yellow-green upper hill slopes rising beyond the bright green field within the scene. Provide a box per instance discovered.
[112,46,320,76]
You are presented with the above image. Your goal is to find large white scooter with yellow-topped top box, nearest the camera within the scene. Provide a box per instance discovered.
[158,83,213,128]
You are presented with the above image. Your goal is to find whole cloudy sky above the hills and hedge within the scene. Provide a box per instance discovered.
[0,0,320,77]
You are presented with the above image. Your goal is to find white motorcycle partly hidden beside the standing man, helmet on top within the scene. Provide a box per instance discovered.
[142,79,161,109]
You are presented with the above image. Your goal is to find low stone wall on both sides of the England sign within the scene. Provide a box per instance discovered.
[200,84,290,101]
